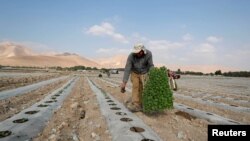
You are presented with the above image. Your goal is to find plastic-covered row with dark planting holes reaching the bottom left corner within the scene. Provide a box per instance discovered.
[0,78,77,141]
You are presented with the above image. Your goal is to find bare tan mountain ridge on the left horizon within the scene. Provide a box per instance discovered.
[0,42,100,67]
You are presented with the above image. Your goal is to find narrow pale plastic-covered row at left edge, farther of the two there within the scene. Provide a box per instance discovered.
[0,76,68,100]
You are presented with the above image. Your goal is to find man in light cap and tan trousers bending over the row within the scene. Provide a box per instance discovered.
[120,43,154,112]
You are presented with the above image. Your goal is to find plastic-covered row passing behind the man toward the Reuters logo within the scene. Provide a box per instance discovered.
[97,79,242,124]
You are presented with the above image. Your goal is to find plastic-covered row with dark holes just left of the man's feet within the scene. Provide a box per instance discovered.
[88,79,162,141]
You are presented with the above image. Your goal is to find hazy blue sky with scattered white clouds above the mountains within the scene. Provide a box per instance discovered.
[0,0,250,71]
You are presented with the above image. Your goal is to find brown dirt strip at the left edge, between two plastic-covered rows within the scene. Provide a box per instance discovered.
[0,79,69,121]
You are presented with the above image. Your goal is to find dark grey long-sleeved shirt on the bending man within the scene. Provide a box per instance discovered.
[123,50,154,83]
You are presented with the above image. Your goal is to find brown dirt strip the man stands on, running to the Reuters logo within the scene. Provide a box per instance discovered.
[91,78,208,141]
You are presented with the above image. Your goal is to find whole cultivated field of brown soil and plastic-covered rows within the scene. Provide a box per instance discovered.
[0,71,250,141]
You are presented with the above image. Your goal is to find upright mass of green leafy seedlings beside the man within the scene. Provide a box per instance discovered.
[142,67,173,113]
